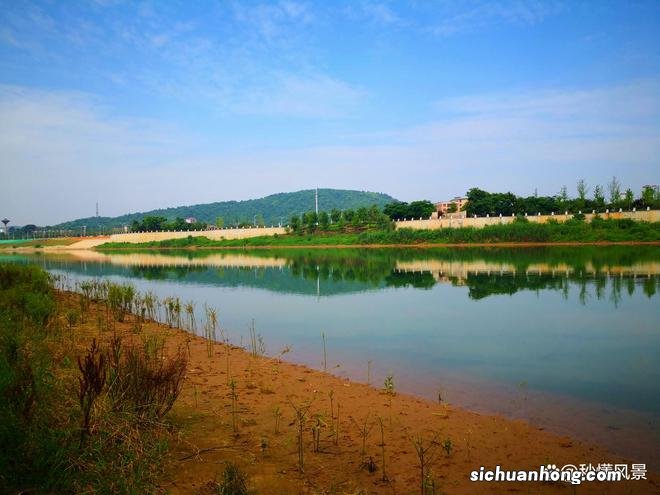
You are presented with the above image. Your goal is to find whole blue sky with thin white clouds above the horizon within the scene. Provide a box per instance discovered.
[0,0,660,224]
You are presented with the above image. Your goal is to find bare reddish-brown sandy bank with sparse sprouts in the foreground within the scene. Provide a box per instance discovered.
[58,294,660,495]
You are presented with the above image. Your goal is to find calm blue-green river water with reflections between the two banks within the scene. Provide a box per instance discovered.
[0,246,660,467]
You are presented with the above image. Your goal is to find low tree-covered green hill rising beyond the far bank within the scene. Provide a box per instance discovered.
[53,189,396,230]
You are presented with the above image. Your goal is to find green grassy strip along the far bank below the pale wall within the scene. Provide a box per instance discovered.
[99,218,660,249]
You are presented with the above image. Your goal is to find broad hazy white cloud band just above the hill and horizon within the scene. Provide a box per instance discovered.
[0,81,660,224]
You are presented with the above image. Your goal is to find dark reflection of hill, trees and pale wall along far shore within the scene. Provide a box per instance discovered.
[6,246,660,300]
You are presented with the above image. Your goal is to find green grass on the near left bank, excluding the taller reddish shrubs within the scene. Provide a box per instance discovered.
[0,264,178,494]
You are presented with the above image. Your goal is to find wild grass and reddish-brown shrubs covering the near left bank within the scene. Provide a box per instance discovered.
[0,264,185,494]
